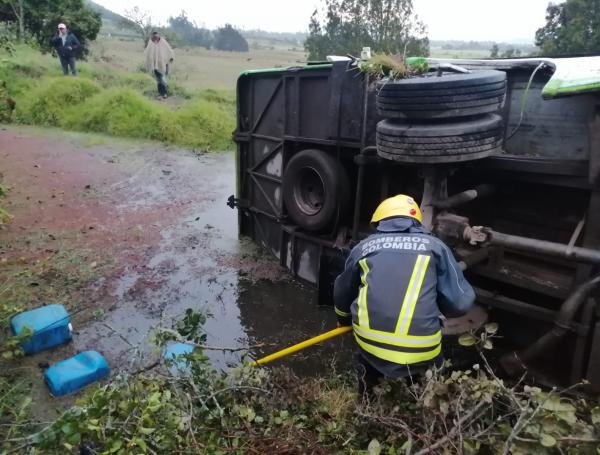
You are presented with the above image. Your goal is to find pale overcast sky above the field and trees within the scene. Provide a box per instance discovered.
[96,0,548,42]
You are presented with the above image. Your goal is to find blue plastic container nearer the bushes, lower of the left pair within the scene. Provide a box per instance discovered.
[44,351,110,397]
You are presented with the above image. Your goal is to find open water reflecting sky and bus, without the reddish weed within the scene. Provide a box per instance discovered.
[75,150,350,374]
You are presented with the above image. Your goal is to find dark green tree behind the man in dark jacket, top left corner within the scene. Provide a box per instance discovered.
[0,0,102,55]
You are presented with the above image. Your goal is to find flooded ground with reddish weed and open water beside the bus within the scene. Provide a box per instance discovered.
[0,128,351,415]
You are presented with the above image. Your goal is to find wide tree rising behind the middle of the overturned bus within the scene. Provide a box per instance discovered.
[304,0,429,60]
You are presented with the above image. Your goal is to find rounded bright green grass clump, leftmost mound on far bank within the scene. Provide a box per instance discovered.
[16,77,101,126]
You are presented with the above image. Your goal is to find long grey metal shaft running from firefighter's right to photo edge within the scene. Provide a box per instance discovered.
[486,230,600,265]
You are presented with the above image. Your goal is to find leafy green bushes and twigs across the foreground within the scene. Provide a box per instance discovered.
[1,310,600,455]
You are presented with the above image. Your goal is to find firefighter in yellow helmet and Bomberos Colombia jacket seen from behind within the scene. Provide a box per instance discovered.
[334,194,475,395]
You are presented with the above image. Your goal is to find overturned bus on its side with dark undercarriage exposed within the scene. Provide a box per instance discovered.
[229,57,600,389]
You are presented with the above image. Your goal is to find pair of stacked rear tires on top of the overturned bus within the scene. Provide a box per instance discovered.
[376,71,506,164]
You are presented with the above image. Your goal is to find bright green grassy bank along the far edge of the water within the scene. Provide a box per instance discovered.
[0,46,235,150]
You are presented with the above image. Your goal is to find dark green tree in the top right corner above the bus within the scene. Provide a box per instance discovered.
[535,0,600,55]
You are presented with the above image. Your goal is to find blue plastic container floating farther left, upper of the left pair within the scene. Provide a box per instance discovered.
[10,304,71,354]
